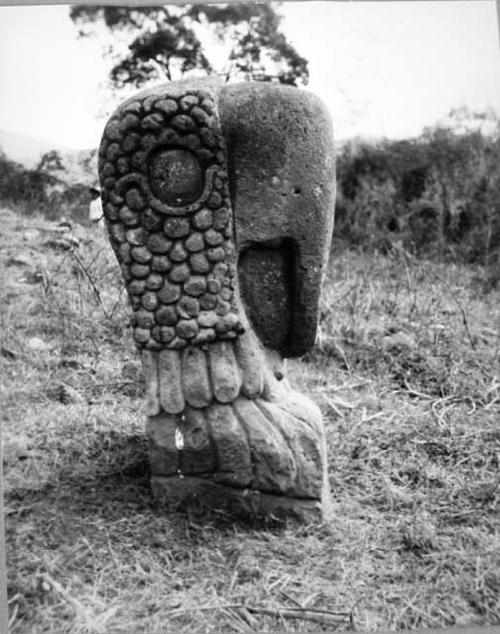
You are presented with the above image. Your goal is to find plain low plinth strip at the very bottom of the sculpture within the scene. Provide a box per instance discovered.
[151,476,329,524]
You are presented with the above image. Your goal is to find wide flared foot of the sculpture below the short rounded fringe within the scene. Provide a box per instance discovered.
[146,394,329,521]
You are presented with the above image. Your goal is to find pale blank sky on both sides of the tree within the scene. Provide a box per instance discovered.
[0,0,500,149]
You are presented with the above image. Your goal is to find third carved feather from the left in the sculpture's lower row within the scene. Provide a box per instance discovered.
[206,403,252,488]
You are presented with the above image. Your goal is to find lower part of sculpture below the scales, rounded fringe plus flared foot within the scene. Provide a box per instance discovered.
[139,324,328,521]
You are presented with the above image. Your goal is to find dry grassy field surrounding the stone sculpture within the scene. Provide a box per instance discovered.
[0,205,500,634]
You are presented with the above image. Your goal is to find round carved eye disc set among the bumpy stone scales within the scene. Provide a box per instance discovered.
[148,149,204,207]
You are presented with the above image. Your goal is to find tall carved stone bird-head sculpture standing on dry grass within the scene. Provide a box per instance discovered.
[99,79,335,521]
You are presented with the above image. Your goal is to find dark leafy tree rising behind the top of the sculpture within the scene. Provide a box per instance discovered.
[70,3,309,88]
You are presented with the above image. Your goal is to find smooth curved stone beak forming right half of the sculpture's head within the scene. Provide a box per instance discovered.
[219,83,335,357]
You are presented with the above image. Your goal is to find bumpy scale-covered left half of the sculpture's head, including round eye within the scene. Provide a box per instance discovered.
[99,79,242,350]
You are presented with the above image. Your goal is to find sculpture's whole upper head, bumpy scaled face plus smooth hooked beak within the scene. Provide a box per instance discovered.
[99,81,334,356]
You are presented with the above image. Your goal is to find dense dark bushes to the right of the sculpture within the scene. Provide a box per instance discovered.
[337,113,500,264]
